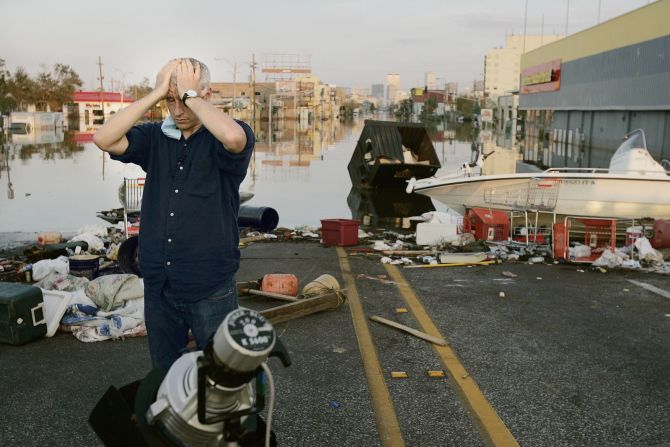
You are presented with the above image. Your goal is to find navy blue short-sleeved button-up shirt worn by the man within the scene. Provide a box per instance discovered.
[112,121,255,301]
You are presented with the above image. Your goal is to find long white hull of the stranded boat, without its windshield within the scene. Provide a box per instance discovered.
[414,173,670,219]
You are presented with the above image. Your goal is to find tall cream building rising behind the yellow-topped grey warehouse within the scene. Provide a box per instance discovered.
[484,34,563,98]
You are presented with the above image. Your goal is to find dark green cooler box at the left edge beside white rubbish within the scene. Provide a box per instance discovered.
[0,282,47,345]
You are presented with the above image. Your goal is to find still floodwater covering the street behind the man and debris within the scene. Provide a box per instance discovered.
[0,118,490,238]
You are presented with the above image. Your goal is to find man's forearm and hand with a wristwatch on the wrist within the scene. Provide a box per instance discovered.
[176,59,247,154]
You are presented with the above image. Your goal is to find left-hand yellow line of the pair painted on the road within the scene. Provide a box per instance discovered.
[337,247,405,447]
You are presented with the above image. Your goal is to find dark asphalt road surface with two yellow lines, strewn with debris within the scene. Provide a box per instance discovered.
[0,243,670,446]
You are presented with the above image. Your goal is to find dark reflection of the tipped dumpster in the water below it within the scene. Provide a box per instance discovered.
[347,188,435,229]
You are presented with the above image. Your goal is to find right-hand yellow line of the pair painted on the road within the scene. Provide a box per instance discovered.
[384,264,519,446]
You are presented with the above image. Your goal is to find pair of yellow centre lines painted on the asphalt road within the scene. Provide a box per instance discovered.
[337,247,519,446]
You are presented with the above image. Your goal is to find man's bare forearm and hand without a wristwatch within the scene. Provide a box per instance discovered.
[93,61,179,155]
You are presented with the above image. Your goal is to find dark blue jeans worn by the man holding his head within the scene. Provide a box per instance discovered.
[144,278,237,369]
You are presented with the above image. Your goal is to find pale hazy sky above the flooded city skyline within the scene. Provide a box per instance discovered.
[0,0,649,92]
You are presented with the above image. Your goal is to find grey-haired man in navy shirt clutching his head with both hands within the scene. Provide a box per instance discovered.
[93,58,255,369]
